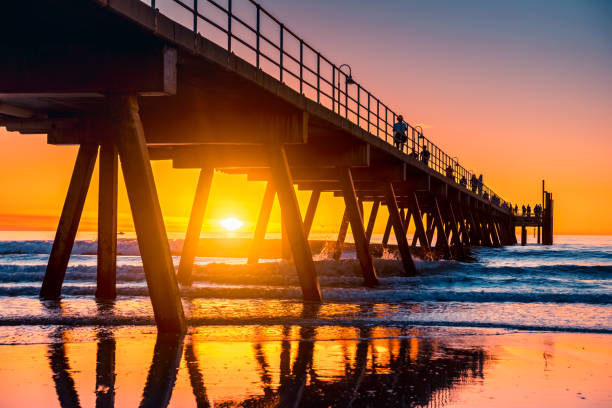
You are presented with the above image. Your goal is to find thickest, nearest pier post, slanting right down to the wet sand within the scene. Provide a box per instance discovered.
[110,96,185,333]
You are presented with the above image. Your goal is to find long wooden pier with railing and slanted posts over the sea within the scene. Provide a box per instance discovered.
[0,0,552,332]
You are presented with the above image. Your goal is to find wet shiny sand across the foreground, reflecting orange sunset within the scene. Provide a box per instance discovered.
[0,325,612,408]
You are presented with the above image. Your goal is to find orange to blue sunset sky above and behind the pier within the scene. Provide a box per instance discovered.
[0,0,612,234]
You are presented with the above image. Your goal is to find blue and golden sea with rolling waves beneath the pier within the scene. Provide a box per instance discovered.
[0,232,612,344]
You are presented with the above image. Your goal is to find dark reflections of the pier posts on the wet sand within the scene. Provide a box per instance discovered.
[48,325,487,407]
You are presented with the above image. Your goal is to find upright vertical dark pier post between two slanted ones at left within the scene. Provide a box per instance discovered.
[96,143,119,299]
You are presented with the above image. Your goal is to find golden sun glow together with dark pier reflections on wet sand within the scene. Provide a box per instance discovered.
[43,325,488,407]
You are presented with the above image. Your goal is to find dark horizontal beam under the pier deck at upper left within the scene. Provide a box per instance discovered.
[0,41,177,98]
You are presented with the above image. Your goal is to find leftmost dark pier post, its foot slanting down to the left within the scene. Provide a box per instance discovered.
[40,145,98,299]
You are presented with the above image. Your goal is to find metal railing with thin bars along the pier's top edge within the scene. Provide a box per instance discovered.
[142,0,511,207]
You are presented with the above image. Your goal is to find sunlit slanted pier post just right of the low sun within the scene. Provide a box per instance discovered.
[268,144,321,302]
